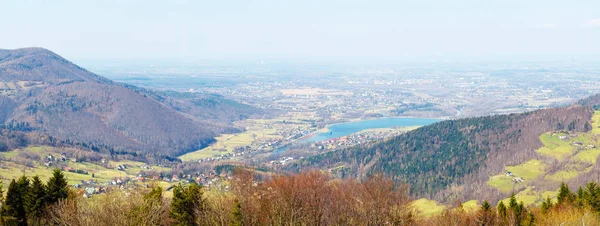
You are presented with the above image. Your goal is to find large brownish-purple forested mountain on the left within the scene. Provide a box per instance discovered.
[0,48,261,161]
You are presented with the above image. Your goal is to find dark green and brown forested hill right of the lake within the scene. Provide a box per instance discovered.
[289,95,600,200]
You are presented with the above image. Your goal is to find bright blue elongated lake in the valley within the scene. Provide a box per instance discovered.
[305,118,440,142]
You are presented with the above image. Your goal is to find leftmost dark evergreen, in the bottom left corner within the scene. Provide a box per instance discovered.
[1,179,27,226]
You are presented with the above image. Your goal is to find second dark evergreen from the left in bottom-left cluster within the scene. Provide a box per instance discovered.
[25,176,46,221]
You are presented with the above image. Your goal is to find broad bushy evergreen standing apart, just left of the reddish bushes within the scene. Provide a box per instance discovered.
[169,183,204,225]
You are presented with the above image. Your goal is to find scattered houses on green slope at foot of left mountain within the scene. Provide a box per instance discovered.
[0,147,232,198]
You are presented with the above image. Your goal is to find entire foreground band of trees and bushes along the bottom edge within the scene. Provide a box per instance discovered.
[5,168,600,226]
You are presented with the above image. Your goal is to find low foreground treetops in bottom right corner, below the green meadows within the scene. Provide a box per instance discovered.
[428,182,600,226]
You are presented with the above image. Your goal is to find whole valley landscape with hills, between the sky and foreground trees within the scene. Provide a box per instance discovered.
[0,49,600,222]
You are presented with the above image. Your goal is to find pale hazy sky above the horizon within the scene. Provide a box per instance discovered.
[0,0,600,59]
